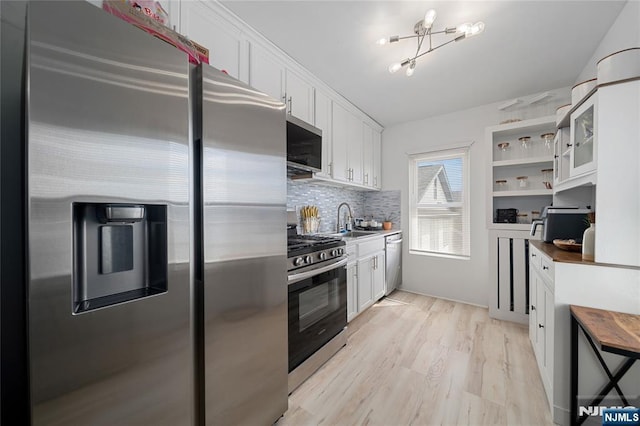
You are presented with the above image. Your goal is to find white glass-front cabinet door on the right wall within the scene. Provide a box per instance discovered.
[567,93,597,177]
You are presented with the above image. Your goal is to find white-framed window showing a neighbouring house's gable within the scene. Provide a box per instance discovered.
[409,147,470,259]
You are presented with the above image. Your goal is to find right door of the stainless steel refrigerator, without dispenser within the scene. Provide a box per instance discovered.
[195,65,288,425]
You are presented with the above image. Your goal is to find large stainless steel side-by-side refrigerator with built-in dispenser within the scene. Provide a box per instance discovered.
[0,1,287,425]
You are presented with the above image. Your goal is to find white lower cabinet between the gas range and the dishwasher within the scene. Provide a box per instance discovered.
[347,236,385,321]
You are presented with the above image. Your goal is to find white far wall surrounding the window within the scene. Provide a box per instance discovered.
[382,87,569,306]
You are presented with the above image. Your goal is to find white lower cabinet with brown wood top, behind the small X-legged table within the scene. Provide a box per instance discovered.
[529,241,640,425]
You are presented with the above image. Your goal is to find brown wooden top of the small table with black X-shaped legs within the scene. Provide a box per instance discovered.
[571,305,640,357]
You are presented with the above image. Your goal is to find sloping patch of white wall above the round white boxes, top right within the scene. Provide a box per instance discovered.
[576,0,640,83]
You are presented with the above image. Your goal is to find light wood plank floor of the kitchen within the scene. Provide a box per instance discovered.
[277,291,553,426]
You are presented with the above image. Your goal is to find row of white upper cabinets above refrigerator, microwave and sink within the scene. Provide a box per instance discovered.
[168,0,382,190]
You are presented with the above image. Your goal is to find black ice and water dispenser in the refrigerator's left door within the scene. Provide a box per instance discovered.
[73,203,167,314]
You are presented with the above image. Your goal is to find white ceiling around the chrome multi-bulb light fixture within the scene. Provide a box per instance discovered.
[221,0,625,126]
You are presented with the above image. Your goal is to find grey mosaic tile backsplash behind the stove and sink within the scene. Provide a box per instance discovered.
[287,180,400,232]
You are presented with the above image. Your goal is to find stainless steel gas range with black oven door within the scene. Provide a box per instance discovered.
[288,233,347,392]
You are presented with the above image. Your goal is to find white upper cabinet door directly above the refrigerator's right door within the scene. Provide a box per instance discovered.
[180,1,247,82]
